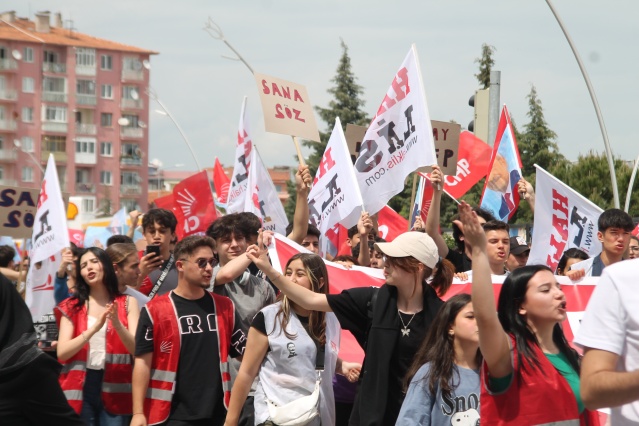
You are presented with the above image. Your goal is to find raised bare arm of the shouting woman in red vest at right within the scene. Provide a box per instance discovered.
[459,202,513,378]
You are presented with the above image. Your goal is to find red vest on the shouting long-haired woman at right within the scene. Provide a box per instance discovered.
[480,336,599,426]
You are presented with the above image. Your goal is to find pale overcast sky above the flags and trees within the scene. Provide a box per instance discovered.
[13,0,639,170]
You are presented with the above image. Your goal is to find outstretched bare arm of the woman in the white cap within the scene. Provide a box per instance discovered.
[246,231,332,312]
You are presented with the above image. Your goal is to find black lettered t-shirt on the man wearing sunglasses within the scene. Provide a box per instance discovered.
[135,293,246,425]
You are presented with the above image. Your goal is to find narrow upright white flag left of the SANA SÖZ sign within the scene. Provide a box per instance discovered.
[226,96,253,213]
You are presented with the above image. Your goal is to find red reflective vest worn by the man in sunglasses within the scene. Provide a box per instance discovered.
[144,292,235,425]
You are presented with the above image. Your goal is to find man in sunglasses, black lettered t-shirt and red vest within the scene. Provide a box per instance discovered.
[131,236,246,426]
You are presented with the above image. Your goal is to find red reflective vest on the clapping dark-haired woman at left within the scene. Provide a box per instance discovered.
[56,295,133,415]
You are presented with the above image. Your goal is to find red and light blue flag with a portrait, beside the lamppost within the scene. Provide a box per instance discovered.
[481,105,522,222]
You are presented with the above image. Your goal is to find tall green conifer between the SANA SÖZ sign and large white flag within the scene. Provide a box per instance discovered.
[285,40,370,221]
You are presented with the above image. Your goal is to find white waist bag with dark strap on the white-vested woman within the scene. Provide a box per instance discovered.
[266,342,325,426]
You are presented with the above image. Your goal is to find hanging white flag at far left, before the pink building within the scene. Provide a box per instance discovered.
[25,154,69,321]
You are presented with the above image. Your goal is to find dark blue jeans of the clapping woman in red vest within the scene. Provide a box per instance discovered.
[80,368,131,426]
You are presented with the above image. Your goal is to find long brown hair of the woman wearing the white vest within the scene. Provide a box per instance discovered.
[269,253,328,345]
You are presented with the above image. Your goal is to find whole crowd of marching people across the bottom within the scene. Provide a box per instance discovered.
[0,161,639,426]
